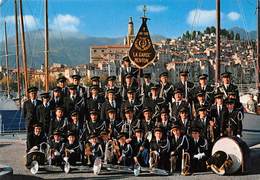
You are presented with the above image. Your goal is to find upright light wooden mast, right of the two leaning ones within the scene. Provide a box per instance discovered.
[44,0,49,92]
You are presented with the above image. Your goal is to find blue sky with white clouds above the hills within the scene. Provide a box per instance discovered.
[0,0,256,38]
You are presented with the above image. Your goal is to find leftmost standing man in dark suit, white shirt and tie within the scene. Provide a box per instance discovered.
[22,87,42,133]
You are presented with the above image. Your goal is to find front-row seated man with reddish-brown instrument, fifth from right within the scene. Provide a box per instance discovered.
[113,132,133,166]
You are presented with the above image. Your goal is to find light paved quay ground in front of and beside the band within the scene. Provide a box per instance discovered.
[0,135,260,180]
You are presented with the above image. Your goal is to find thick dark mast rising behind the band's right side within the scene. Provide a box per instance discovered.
[215,0,220,83]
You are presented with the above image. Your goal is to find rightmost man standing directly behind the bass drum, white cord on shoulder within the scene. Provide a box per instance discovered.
[223,99,244,137]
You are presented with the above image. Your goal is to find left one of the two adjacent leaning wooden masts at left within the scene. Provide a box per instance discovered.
[14,0,21,108]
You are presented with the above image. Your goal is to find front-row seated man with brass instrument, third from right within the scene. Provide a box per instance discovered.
[149,127,170,170]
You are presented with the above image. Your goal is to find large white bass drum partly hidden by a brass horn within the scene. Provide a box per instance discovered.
[212,137,250,174]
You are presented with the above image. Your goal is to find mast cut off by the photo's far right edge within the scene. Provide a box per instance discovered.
[255,0,260,103]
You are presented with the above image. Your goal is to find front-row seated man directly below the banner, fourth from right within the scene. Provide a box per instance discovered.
[131,129,149,167]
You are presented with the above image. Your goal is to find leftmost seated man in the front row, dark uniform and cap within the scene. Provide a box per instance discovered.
[25,123,47,167]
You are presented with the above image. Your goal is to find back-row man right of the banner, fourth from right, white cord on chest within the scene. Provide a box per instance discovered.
[159,72,174,102]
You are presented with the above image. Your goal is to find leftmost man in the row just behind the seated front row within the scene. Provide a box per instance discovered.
[49,107,68,136]
